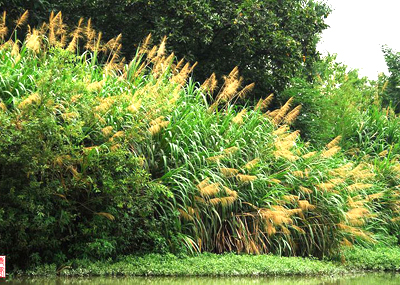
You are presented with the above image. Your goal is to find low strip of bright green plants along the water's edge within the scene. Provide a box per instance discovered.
[17,247,400,276]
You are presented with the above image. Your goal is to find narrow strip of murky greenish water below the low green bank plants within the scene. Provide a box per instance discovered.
[0,273,400,285]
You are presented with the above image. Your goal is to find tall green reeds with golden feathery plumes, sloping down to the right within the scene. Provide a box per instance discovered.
[0,13,400,268]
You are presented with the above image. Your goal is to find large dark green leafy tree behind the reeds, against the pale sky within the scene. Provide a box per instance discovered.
[0,0,330,97]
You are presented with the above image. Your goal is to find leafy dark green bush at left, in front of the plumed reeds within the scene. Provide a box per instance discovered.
[0,32,171,269]
